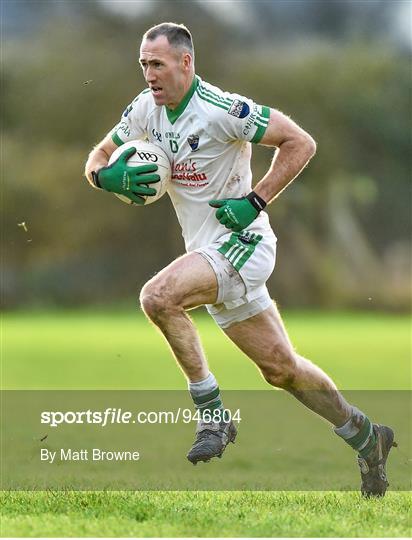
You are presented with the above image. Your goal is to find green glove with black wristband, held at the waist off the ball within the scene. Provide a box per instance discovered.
[209,191,266,232]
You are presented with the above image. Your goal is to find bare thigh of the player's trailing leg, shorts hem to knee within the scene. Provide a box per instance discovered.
[223,303,293,368]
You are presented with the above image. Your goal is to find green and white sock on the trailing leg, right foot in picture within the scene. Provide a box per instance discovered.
[334,407,376,458]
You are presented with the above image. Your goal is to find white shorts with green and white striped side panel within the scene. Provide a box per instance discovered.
[195,231,276,328]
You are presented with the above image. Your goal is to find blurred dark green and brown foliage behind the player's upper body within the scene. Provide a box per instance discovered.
[2,2,411,309]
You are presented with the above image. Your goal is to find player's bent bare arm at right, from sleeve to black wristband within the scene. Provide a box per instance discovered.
[254,109,316,203]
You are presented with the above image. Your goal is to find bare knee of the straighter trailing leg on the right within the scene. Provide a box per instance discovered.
[261,343,297,390]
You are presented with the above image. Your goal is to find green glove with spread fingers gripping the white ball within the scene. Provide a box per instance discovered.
[92,148,160,204]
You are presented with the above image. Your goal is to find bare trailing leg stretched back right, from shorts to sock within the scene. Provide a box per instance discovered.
[225,305,352,426]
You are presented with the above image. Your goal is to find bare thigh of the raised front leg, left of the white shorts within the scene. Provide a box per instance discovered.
[145,253,217,309]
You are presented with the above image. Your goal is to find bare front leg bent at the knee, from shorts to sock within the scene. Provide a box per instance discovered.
[140,253,217,382]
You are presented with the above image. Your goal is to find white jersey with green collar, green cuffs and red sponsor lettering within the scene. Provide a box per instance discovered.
[111,76,273,251]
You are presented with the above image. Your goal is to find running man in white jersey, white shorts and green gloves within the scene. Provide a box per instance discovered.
[85,23,396,496]
